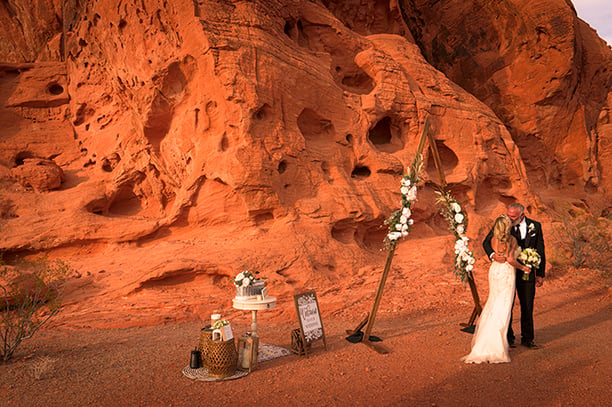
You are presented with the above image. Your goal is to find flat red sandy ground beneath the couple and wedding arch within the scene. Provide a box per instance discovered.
[0,271,612,406]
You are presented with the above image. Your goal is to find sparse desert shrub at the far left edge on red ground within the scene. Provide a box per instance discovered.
[0,258,71,362]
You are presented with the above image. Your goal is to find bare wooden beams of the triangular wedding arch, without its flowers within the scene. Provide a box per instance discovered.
[346,117,482,354]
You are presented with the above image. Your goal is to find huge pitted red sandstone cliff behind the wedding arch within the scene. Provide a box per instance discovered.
[0,0,612,326]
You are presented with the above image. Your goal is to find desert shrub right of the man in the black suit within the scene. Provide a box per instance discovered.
[552,208,612,273]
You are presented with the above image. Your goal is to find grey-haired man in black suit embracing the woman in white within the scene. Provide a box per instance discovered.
[482,203,546,349]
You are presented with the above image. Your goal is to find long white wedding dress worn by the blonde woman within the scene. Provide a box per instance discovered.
[461,253,520,363]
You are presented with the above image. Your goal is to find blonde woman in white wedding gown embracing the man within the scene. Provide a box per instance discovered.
[461,215,529,363]
